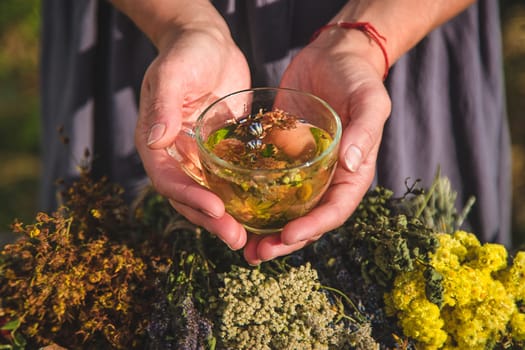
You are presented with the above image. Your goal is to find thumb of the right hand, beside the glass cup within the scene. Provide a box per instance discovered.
[340,84,391,172]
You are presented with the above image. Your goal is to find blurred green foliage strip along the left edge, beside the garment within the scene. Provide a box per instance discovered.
[0,0,40,232]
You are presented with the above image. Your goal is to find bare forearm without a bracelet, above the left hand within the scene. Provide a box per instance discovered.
[110,0,229,48]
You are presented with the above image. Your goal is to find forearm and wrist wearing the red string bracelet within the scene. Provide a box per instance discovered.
[312,0,475,76]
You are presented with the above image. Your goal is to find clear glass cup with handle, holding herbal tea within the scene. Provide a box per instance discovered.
[168,88,341,234]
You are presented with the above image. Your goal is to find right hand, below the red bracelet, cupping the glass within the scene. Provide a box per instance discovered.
[244,29,390,264]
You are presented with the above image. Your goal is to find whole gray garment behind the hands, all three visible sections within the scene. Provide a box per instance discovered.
[42,0,511,245]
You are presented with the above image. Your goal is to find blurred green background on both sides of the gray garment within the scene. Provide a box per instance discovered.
[0,0,525,246]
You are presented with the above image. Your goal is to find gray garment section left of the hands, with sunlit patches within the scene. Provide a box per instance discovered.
[41,0,156,210]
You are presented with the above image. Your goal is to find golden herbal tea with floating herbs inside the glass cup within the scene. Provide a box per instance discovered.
[203,110,337,233]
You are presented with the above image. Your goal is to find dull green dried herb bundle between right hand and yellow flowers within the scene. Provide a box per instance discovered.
[294,175,466,347]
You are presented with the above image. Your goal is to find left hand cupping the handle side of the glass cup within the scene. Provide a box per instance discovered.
[135,24,250,249]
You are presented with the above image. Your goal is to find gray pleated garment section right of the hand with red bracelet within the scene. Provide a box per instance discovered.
[377,4,511,245]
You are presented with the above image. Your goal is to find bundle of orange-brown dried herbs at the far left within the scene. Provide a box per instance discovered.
[0,172,166,349]
